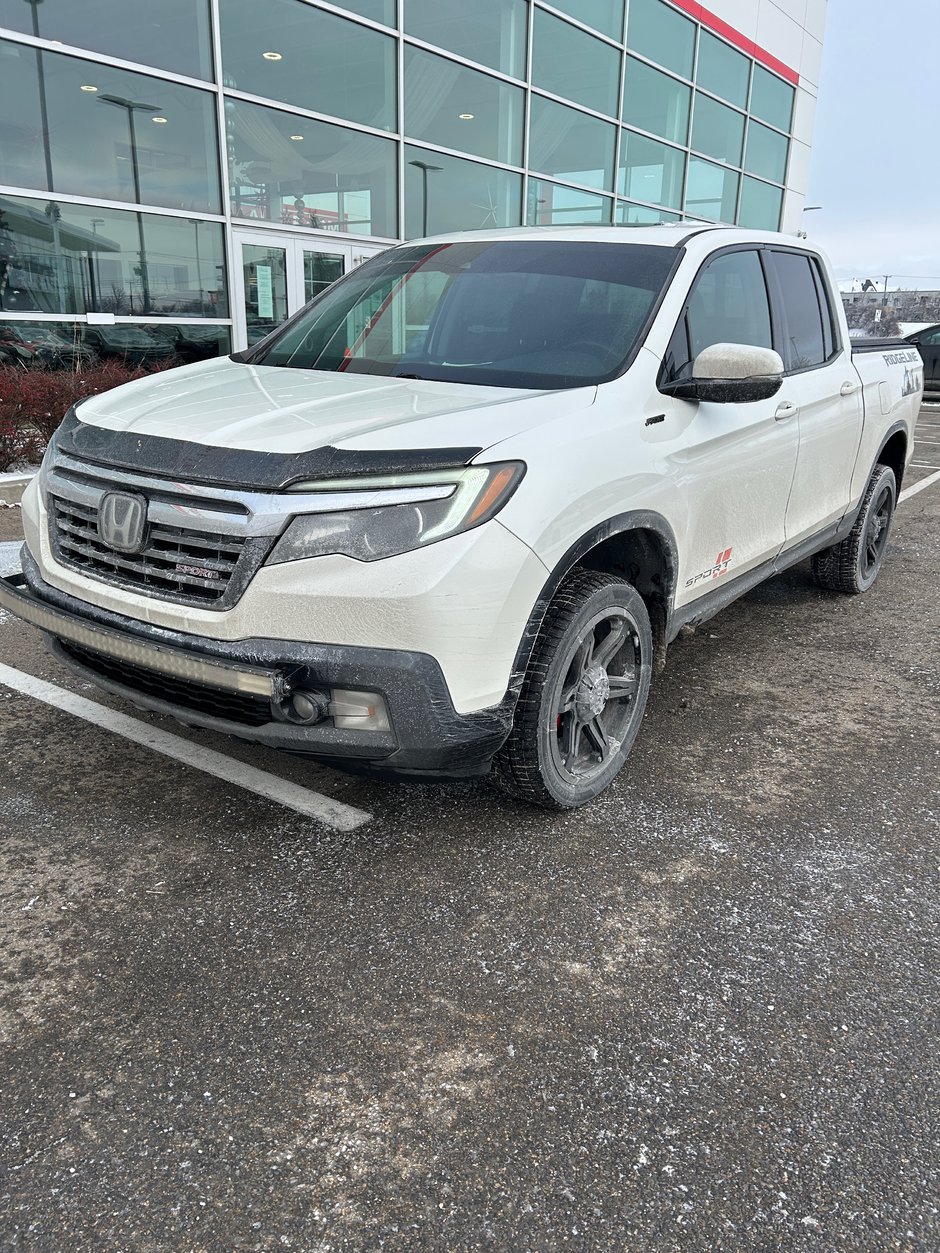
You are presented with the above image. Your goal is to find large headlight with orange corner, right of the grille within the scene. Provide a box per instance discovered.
[268,461,525,565]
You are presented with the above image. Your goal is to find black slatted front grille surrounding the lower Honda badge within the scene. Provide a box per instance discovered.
[49,495,246,606]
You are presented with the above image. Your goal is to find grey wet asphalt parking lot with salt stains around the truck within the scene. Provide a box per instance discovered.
[0,406,940,1253]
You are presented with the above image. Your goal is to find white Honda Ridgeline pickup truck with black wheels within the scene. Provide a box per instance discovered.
[0,223,922,808]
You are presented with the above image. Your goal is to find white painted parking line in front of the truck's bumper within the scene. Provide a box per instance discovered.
[0,663,372,831]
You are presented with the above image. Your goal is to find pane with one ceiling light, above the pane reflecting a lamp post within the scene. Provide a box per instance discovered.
[405,48,523,165]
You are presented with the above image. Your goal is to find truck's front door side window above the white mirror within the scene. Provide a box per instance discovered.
[667,252,773,375]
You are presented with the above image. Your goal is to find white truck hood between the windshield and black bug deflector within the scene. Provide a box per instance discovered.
[78,357,597,454]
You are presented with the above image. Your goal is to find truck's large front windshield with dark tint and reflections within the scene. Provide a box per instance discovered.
[248,239,677,388]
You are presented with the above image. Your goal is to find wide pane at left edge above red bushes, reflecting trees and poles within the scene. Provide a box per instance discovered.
[0,195,228,317]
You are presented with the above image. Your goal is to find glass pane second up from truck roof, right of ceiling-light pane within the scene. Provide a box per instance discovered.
[529,95,617,192]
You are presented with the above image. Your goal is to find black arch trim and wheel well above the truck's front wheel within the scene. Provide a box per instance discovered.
[510,509,679,694]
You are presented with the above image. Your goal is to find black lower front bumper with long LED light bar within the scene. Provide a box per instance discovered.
[0,548,515,778]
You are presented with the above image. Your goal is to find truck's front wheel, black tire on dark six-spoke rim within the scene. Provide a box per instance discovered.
[494,570,653,809]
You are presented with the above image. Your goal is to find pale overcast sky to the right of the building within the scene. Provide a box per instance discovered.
[803,0,940,288]
